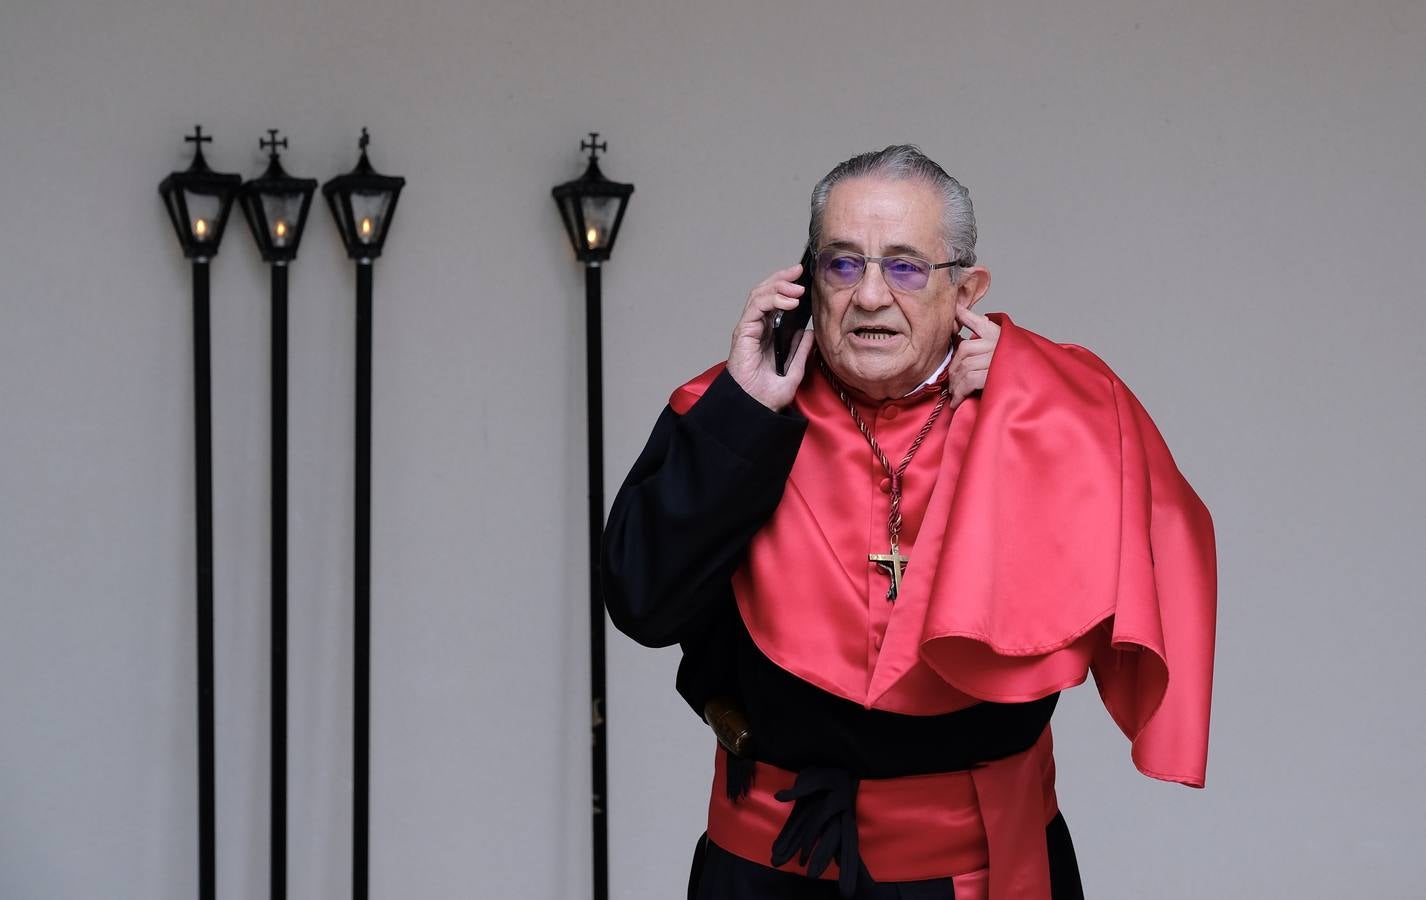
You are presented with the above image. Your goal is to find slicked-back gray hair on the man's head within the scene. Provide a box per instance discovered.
[807,144,975,268]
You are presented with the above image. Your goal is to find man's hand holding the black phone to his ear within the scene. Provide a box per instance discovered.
[727,264,821,412]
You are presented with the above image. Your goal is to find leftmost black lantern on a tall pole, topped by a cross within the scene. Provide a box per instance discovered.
[158,126,242,900]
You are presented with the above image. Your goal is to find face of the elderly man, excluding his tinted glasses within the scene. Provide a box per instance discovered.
[813,177,988,399]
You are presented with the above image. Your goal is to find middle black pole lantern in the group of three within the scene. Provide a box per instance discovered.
[238,128,317,900]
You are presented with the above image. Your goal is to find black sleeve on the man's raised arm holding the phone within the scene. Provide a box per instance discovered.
[600,371,807,646]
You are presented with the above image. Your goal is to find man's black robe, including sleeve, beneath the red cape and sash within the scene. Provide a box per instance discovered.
[600,372,1082,900]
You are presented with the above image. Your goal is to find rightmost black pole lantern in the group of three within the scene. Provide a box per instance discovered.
[322,128,406,900]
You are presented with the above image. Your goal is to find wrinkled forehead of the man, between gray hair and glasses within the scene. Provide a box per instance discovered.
[821,175,944,258]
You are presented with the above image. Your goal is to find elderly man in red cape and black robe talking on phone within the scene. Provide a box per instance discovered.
[603,147,1216,900]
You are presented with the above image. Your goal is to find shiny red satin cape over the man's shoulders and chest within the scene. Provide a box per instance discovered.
[669,312,1216,787]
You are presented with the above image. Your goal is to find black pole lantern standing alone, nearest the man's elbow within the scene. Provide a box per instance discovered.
[552,131,633,900]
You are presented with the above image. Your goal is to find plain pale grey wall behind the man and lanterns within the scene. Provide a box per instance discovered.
[0,0,1426,900]
